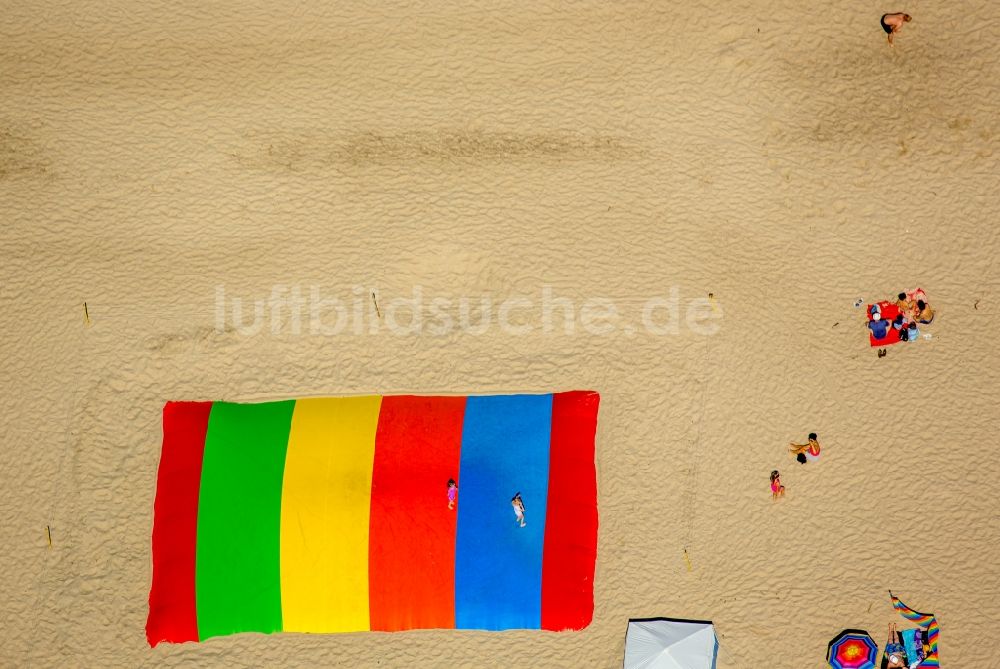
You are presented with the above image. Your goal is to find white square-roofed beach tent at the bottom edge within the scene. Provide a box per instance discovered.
[625,618,719,669]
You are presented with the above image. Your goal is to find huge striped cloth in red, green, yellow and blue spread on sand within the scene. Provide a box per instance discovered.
[146,391,600,646]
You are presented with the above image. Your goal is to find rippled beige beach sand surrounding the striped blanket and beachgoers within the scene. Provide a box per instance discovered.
[0,0,1000,669]
